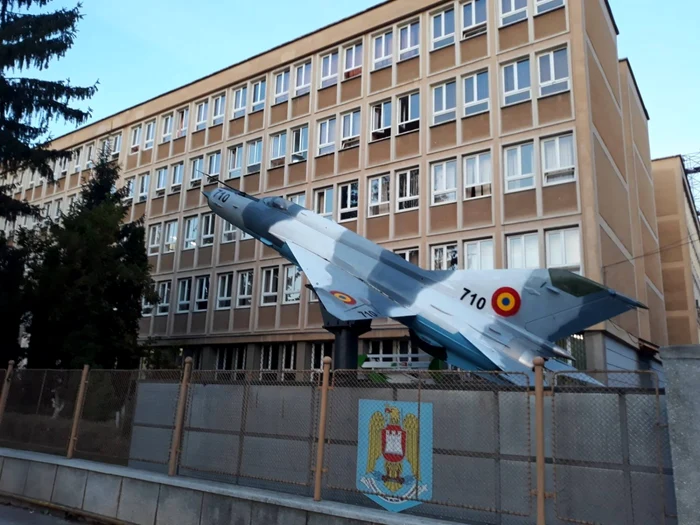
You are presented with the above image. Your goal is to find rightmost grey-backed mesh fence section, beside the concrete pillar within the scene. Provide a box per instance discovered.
[550,371,675,525]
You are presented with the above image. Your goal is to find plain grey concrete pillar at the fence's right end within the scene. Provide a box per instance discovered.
[661,345,700,525]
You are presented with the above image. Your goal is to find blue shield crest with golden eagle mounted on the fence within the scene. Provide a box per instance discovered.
[356,399,433,512]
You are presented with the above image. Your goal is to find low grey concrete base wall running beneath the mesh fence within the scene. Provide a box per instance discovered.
[0,448,464,525]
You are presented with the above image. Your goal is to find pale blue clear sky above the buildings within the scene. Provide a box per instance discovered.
[31,0,700,158]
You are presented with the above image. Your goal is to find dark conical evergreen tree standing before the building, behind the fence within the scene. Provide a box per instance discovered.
[20,154,156,368]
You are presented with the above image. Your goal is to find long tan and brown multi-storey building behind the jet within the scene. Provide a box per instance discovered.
[0,0,667,371]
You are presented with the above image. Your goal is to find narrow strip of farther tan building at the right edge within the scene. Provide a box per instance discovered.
[652,156,700,345]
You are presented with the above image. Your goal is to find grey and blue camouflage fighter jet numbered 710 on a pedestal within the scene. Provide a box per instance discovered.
[204,187,646,374]
